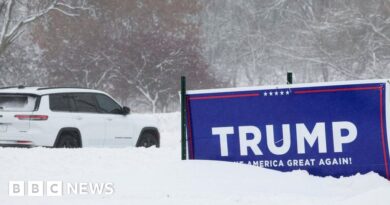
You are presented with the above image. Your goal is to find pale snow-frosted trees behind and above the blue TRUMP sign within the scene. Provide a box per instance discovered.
[200,0,390,86]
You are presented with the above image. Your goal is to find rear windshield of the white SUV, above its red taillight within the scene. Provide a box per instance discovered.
[0,94,38,112]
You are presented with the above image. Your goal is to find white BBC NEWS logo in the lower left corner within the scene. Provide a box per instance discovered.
[8,181,114,197]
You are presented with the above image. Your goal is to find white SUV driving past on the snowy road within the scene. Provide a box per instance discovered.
[0,86,160,148]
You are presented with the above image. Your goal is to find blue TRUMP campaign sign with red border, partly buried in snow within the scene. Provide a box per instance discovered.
[186,83,390,179]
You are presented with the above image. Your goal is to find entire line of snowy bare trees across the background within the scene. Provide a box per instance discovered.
[0,0,390,112]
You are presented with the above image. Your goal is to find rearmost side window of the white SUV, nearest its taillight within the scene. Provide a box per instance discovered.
[49,93,75,112]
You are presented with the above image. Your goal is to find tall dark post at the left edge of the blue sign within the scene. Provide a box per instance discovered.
[180,76,187,160]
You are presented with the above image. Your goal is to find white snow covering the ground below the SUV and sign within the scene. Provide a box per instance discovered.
[0,113,390,205]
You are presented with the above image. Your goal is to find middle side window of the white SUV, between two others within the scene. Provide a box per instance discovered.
[73,93,99,113]
